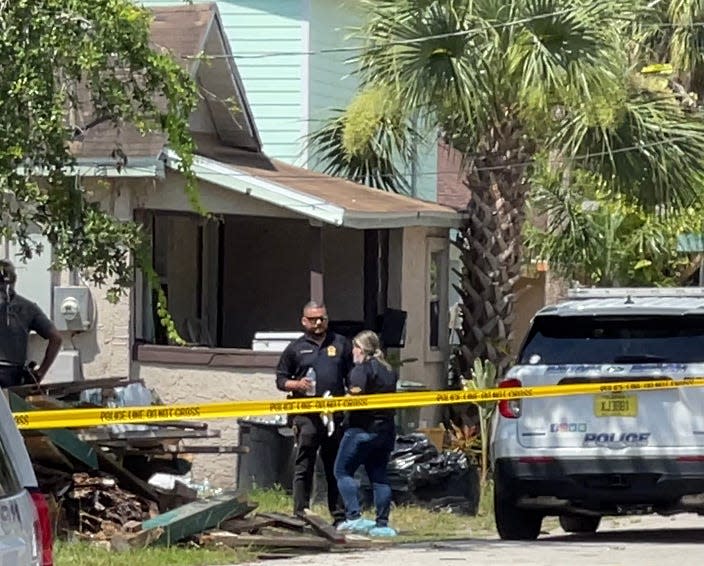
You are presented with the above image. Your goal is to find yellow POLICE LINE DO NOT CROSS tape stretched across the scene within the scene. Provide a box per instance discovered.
[14,377,704,430]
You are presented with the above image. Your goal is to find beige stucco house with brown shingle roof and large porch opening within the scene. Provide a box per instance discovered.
[19,4,461,485]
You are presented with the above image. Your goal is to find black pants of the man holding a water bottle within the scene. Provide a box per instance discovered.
[293,414,345,522]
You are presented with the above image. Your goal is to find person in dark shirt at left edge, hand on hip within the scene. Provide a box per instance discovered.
[0,259,62,387]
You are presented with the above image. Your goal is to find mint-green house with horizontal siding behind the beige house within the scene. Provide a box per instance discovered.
[136,0,437,201]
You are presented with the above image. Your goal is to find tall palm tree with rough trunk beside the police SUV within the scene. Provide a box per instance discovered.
[312,0,704,373]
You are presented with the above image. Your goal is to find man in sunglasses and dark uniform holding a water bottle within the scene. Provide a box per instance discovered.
[276,301,352,525]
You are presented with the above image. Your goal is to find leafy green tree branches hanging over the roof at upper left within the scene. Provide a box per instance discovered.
[0,0,202,342]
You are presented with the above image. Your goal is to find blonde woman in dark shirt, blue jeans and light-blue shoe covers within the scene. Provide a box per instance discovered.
[335,330,398,537]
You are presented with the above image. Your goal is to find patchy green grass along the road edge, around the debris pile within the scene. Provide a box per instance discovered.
[54,486,495,566]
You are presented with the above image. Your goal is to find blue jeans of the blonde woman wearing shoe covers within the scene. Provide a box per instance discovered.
[335,423,396,527]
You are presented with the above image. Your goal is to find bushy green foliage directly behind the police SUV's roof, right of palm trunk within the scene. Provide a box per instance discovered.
[524,166,704,287]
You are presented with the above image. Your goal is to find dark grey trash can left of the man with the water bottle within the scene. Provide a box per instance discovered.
[237,418,294,493]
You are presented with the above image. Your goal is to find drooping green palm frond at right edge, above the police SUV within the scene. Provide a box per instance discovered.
[549,82,704,207]
